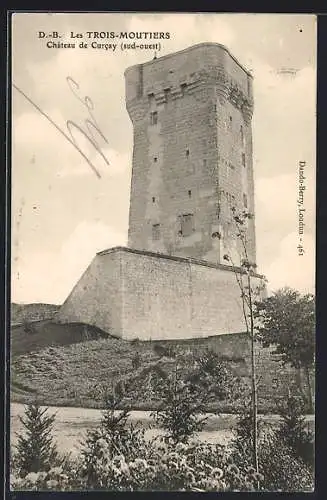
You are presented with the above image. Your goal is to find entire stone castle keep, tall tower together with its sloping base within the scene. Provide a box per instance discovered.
[57,43,261,339]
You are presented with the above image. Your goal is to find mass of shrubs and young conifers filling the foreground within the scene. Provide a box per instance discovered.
[11,352,313,492]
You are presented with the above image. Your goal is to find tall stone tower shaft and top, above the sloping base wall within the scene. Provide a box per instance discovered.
[125,43,256,265]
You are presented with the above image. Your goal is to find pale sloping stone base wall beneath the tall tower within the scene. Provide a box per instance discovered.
[57,247,266,340]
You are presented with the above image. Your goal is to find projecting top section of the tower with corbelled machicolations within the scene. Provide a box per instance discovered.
[125,43,253,120]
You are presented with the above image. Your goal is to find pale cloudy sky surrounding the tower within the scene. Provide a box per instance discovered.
[11,13,316,304]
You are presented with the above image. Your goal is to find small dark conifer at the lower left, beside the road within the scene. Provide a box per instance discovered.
[15,404,58,477]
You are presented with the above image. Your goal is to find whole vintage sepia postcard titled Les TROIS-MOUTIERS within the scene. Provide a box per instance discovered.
[8,12,317,492]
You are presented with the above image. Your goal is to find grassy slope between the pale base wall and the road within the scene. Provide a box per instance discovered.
[11,322,312,412]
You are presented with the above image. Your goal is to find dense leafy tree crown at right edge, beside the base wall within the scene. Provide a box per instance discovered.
[255,288,315,368]
